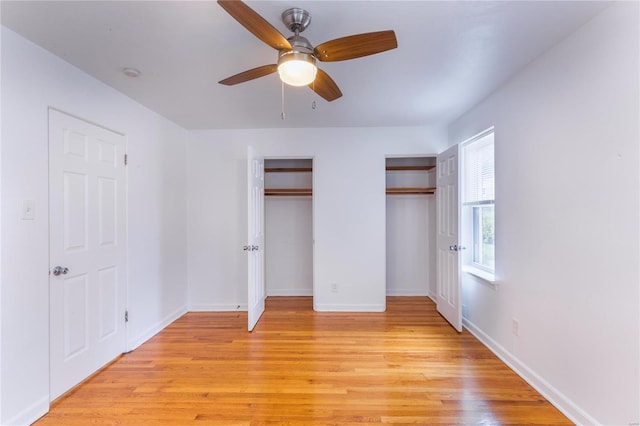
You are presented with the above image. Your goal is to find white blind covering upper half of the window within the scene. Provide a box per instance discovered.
[463,132,495,204]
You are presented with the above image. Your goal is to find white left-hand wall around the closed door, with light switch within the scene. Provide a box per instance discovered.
[0,28,187,425]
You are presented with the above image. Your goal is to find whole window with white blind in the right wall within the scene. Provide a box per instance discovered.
[462,129,496,281]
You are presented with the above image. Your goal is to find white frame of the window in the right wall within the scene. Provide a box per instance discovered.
[460,127,497,284]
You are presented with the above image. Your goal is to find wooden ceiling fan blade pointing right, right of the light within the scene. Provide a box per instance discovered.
[314,30,398,62]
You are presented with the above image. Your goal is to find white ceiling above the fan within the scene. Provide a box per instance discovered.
[0,0,608,129]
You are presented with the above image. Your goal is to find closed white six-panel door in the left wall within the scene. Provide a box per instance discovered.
[49,110,126,400]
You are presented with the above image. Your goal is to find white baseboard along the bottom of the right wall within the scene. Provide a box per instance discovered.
[462,318,601,425]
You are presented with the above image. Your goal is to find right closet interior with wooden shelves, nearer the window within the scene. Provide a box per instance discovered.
[386,157,436,298]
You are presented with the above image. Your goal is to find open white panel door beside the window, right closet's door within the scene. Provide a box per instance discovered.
[436,145,462,331]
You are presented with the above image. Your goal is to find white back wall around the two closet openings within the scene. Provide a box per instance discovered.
[187,128,446,311]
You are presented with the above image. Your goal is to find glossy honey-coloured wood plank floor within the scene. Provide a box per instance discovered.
[35,297,571,426]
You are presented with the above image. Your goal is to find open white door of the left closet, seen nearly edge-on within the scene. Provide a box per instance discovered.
[245,147,267,331]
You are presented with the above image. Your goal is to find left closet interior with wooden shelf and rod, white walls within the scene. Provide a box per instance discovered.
[264,159,313,296]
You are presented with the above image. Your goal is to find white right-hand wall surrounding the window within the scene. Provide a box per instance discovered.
[449,2,640,425]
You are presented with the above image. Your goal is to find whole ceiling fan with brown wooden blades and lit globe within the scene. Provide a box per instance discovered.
[218,0,398,102]
